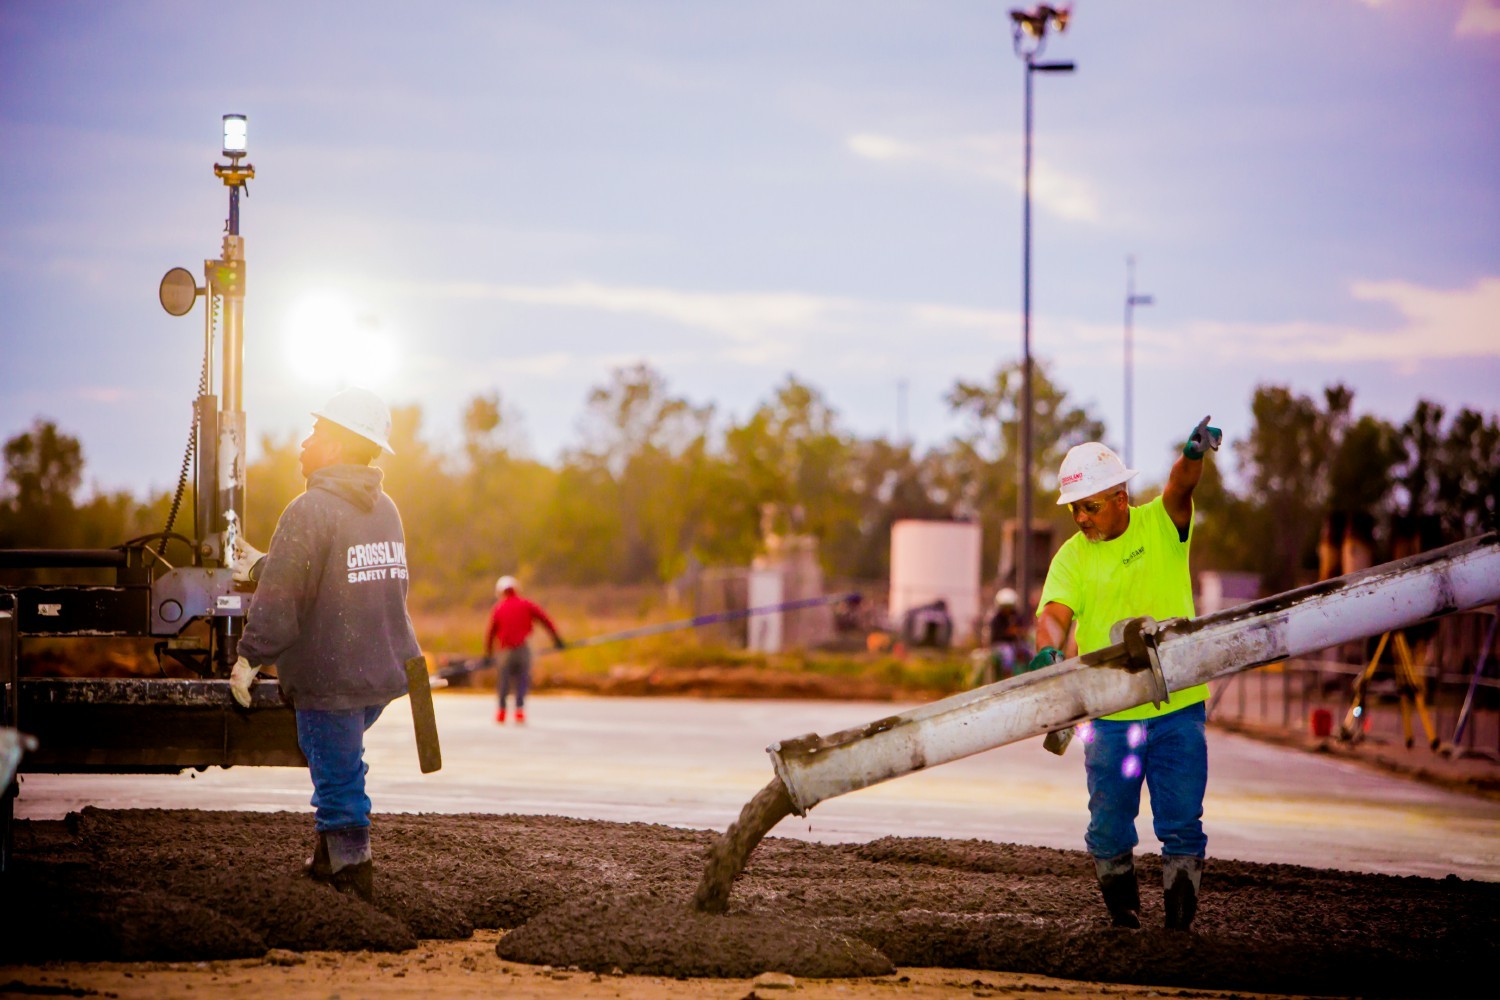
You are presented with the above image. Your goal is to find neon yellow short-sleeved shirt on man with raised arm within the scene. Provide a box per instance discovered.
[1038,496,1209,720]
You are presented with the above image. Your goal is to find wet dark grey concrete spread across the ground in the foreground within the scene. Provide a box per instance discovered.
[0,810,1500,994]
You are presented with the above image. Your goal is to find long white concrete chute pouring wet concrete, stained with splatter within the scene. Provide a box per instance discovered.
[768,532,1500,816]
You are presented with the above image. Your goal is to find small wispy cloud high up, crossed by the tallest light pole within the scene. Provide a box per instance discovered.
[845,132,1101,222]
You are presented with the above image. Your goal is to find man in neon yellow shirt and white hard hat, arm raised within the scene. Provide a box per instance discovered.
[1028,417,1223,931]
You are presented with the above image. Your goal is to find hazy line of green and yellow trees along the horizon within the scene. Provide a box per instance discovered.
[0,363,1500,601]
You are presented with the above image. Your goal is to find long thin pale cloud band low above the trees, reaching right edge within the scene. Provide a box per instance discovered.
[393,277,1500,378]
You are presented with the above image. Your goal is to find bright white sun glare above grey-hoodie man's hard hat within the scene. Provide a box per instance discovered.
[285,292,396,387]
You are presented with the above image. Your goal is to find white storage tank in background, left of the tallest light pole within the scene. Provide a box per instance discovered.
[890,520,983,643]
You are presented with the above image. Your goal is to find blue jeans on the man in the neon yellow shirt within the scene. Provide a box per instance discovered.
[1083,702,1209,859]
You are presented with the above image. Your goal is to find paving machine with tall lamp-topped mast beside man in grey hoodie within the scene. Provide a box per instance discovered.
[0,114,306,870]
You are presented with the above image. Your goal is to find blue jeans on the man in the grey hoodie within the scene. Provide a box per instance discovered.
[297,705,386,832]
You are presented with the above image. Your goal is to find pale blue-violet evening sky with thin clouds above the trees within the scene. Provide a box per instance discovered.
[0,0,1500,493]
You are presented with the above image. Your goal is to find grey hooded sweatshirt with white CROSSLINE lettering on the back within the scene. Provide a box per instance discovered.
[240,465,420,711]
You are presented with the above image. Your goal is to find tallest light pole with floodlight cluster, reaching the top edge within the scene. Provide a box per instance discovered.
[1011,3,1073,618]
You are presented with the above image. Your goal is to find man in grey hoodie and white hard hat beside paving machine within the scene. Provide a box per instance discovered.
[230,387,420,901]
